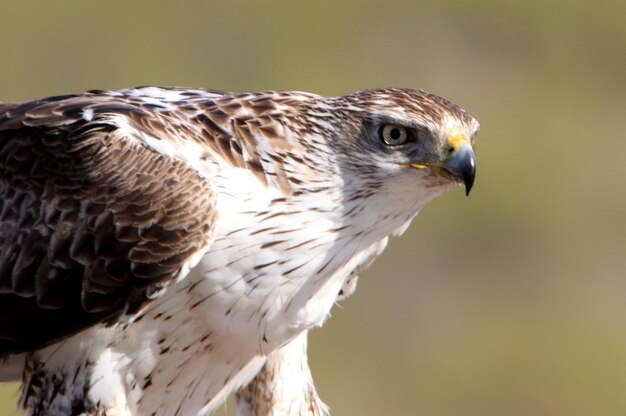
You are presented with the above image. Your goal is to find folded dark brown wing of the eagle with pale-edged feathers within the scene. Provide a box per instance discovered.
[0,93,215,354]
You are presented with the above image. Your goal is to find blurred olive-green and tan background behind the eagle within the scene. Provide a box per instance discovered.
[0,0,626,416]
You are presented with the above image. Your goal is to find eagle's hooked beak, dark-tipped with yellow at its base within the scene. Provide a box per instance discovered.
[441,129,476,195]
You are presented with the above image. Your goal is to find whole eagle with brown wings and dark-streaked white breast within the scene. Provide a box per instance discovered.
[0,86,479,416]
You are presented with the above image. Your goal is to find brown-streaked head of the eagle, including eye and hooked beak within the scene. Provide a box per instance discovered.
[332,88,479,194]
